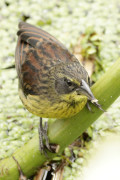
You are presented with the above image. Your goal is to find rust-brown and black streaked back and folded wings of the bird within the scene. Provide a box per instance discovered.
[15,22,76,93]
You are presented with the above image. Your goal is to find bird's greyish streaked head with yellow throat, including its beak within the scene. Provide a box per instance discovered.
[51,62,98,103]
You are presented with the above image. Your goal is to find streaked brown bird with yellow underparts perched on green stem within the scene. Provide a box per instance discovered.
[15,22,102,153]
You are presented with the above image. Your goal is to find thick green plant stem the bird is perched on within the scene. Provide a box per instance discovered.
[0,59,120,180]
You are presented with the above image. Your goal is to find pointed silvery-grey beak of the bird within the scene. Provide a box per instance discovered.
[77,79,98,103]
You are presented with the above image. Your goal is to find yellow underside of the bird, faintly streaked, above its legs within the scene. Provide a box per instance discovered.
[19,90,87,119]
